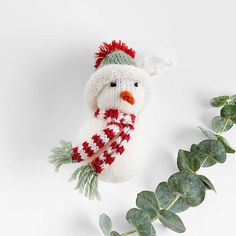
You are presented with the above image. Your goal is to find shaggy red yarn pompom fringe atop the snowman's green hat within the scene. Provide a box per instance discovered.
[95,40,135,68]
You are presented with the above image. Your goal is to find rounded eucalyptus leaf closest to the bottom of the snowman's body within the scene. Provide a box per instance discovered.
[136,191,160,219]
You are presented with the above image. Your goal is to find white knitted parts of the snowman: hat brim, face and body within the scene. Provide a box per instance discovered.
[74,64,151,182]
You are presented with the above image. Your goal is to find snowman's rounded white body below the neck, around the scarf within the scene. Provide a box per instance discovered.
[76,117,146,183]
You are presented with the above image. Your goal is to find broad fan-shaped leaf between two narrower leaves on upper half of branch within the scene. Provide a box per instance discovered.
[191,139,226,167]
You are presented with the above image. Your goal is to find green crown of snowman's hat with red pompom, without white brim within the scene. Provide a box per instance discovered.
[95,40,135,69]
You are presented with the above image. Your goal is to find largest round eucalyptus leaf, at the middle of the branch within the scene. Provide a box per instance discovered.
[168,172,205,207]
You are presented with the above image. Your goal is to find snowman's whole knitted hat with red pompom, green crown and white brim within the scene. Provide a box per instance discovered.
[84,40,150,111]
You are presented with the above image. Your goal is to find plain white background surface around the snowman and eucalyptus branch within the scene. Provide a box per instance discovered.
[0,0,236,236]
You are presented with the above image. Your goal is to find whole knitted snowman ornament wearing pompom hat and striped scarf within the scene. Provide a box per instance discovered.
[50,41,162,199]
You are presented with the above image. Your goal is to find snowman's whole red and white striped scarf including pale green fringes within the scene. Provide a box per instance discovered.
[49,109,136,200]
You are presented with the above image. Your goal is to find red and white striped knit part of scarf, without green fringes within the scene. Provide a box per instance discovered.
[72,109,136,174]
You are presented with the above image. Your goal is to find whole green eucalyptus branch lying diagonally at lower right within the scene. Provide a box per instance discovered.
[99,95,236,236]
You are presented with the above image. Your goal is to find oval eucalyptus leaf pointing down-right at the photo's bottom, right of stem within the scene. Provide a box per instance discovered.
[159,210,186,233]
